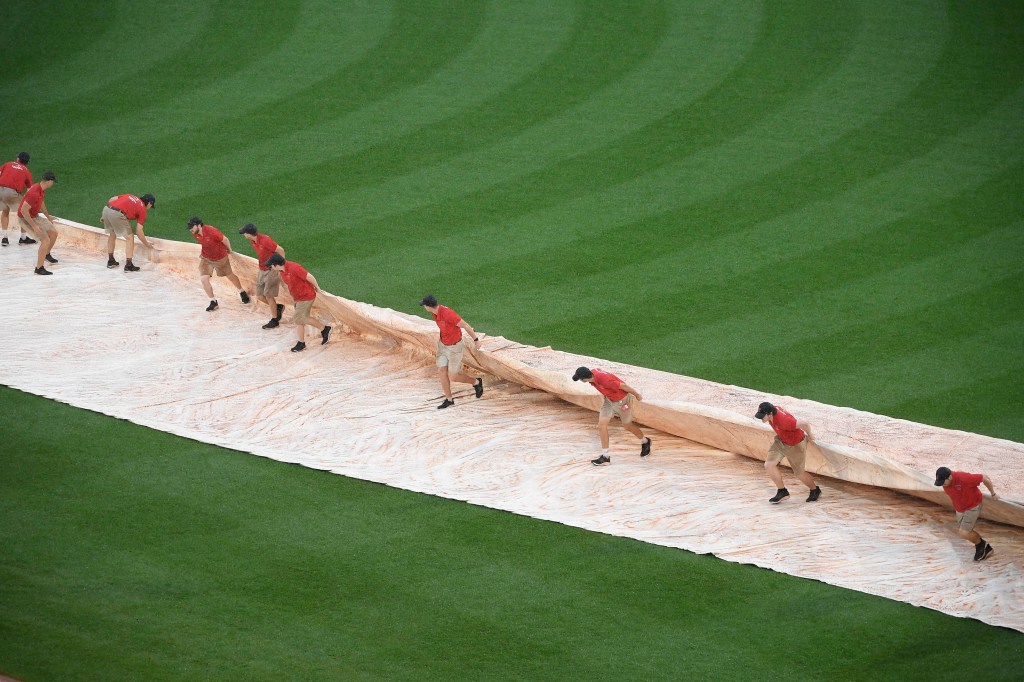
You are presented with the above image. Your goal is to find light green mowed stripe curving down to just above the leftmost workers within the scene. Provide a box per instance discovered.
[28,0,391,163]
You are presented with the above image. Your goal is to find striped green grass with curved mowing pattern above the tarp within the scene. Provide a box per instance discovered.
[0,0,1024,432]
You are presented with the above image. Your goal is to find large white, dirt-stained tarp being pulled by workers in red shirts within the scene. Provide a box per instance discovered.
[0,221,1024,632]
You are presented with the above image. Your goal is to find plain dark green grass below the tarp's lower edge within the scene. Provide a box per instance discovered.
[0,388,1024,681]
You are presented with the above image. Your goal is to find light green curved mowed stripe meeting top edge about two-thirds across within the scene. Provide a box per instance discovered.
[256,3,760,262]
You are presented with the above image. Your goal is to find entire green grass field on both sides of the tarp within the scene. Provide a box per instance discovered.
[0,0,1024,681]
